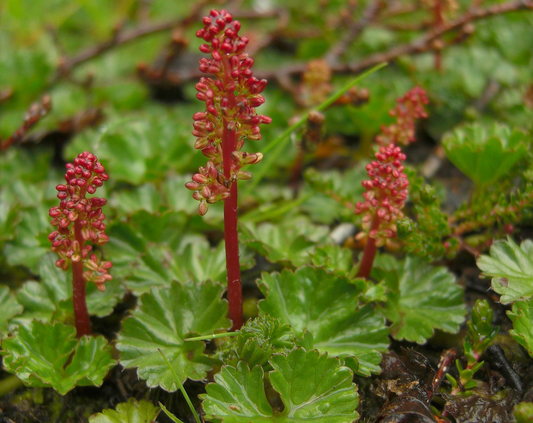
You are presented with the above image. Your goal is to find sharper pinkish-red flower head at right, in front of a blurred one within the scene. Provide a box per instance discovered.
[355,144,409,246]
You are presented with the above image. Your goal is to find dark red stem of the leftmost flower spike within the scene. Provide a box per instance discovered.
[72,221,92,338]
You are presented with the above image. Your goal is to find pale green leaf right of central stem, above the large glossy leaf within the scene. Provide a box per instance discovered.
[241,217,328,267]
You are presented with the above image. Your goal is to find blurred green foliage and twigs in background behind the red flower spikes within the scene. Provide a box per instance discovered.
[0,0,533,284]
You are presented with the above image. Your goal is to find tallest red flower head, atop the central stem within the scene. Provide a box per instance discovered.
[186,10,272,215]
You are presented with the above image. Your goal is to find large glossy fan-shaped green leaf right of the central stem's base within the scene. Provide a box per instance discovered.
[258,267,389,375]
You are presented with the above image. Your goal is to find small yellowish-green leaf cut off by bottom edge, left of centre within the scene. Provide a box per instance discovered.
[89,398,160,423]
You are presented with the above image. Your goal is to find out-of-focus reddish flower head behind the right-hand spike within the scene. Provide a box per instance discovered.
[376,87,429,145]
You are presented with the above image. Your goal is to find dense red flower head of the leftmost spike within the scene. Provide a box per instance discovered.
[48,151,112,291]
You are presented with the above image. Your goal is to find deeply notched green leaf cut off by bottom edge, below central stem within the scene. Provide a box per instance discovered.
[202,348,359,423]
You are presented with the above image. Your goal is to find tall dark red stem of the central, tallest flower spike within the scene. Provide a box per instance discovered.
[222,58,242,331]
